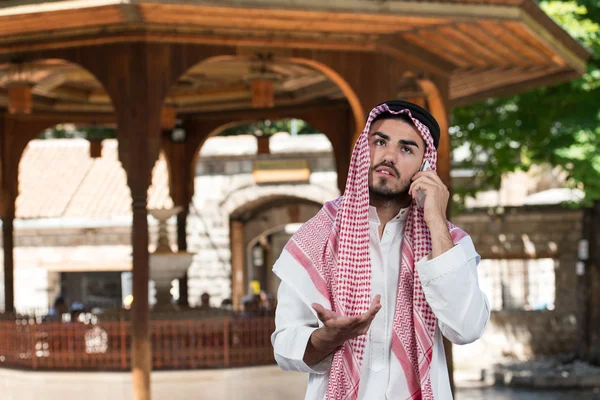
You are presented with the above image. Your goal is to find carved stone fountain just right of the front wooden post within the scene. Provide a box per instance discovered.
[148,206,193,307]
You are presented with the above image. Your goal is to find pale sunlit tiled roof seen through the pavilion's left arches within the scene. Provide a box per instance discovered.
[16,139,173,220]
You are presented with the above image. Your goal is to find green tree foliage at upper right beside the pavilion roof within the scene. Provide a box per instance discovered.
[451,0,600,204]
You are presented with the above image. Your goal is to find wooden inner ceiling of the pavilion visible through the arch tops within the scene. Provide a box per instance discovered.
[0,57,344,114]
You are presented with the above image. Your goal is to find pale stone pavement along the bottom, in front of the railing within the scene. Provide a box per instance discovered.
[0,366,600,400]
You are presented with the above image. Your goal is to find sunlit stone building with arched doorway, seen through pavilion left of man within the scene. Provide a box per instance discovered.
[0,133,339,311]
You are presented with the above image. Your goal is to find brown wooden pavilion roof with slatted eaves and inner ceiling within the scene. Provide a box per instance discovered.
[0,0,588,113]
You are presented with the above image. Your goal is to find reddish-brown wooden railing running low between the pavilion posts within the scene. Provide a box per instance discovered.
[0,316,275,371]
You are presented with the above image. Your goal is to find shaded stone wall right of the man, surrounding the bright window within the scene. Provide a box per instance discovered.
[453,206,583,367]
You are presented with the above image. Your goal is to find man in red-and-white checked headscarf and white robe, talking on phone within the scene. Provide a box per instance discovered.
[272,100,490,400]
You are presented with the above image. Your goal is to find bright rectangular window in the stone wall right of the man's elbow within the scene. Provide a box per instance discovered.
[478,258,557,311]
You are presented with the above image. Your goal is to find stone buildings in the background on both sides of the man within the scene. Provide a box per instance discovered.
[2,133,584,367]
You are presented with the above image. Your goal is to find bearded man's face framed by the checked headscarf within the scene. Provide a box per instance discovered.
[369,119,425,198]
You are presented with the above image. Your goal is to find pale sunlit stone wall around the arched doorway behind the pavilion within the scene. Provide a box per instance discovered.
[177,151,339,306]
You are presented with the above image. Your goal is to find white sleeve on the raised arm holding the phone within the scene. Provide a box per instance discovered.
[416,237,490,344]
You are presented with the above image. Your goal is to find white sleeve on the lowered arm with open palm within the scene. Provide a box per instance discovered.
[271,282,333,374]
